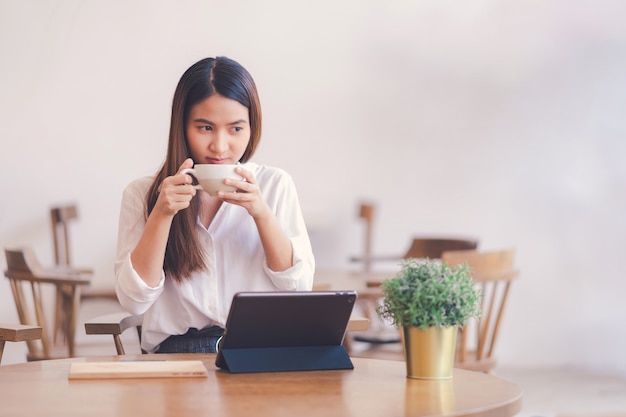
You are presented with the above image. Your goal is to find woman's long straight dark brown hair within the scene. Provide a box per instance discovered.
[146,57,261,282]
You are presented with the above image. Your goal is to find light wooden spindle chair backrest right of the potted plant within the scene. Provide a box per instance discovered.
[441,249,518,372]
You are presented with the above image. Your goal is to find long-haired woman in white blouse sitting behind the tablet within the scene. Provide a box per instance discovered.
[115,57,315,353]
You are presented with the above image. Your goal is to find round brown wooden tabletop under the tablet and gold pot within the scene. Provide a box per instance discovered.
[0,354,522,417]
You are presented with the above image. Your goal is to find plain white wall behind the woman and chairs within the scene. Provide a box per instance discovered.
[0,0,626,374]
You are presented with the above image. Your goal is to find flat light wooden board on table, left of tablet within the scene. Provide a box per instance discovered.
[69,360,208,379]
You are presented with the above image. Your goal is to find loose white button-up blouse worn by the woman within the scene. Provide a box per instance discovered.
[115,162,315,352]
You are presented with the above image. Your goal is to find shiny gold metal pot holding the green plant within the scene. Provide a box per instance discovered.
[403,326,458,379]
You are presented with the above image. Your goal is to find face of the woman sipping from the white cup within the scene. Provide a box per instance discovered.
[186,94,250,164]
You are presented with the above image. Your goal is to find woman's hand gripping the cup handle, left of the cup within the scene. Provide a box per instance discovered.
[154,158,196,216]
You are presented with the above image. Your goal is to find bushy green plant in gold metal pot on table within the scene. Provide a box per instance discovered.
[377,259,481,379]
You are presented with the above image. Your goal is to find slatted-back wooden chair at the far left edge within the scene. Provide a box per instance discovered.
[4,247,90,360]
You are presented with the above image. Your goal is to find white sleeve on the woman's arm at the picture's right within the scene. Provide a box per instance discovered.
[263,169,315,291]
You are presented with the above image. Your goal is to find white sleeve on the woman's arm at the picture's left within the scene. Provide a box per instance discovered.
[115,178,165,314]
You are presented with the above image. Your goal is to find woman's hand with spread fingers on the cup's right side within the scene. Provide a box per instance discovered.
[217,167,271,220]
